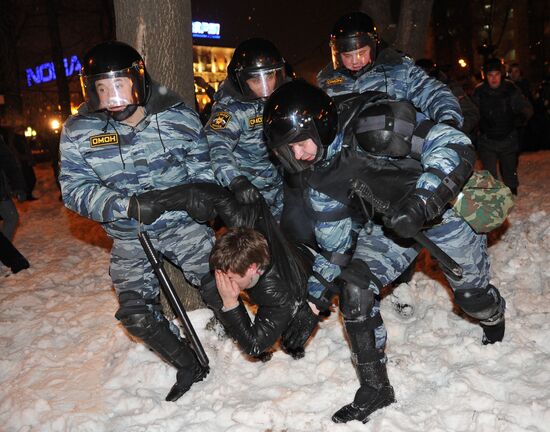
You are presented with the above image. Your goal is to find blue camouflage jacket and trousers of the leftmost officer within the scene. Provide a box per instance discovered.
[59,85,214,310]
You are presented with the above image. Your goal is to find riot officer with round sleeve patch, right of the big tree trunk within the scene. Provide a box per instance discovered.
[204,38,286,218]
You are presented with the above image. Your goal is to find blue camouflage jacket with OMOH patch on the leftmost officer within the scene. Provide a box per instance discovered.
[59,84,214,239]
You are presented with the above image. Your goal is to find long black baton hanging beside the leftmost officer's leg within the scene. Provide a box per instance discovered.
[138,231,208,368]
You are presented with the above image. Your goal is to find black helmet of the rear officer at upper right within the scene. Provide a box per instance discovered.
[330,12,380,76]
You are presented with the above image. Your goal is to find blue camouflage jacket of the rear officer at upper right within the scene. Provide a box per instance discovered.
[317,48,463,126]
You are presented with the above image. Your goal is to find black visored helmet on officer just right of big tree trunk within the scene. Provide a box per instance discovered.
[227,38,285,100]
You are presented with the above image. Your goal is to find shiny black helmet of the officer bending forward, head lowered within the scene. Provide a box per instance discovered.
[263,80,338,173]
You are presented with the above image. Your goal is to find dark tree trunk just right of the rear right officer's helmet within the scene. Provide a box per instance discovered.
[394,0,433,58]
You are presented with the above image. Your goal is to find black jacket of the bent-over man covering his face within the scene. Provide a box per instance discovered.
[148,183,313,356]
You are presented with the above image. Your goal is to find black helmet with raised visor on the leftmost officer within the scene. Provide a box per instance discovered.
[80,41,151,120]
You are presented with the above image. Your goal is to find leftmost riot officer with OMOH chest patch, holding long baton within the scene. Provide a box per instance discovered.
[59,41,214,401]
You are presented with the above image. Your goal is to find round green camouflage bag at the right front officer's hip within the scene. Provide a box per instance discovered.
[453,170,514,233]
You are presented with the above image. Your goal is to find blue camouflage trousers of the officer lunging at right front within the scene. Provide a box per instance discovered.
[353,210,490,348]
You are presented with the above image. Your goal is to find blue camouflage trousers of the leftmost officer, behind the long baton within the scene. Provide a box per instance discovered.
[109,220,214,299]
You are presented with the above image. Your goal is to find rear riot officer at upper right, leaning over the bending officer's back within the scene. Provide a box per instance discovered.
[317,12,463,127]
